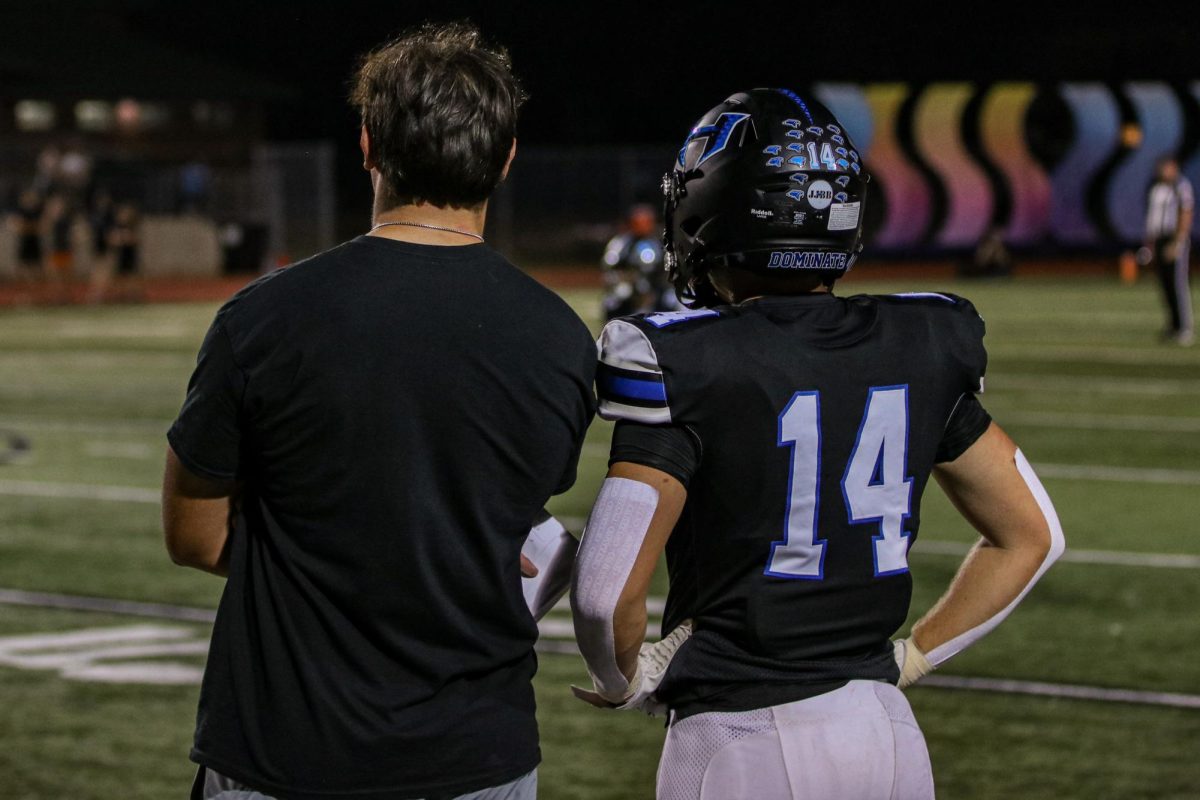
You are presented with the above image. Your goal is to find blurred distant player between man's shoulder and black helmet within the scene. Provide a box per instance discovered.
[601,203,679,320]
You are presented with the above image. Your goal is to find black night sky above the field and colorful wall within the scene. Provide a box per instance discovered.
[0,0,1200,245]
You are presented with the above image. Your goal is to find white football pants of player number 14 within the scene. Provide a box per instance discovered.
[658,680,934,800]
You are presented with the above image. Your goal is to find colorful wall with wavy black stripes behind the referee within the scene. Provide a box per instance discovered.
[814,82,1200,252]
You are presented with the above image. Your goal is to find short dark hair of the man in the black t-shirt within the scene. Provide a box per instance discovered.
[350,23,526,207]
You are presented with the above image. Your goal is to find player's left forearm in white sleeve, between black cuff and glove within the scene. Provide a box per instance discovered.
[571,462,688,703]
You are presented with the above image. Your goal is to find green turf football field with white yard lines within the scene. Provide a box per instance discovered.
[0,273,1200,800]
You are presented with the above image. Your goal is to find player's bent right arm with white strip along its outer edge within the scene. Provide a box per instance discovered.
[896,423,1066,686]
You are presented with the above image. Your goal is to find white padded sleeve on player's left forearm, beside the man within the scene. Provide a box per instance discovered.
[571,477,659,702]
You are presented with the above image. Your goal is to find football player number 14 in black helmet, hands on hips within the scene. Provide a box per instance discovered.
[571,89,1063,800]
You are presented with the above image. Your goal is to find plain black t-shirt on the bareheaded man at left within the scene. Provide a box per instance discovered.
[168,236,595,799]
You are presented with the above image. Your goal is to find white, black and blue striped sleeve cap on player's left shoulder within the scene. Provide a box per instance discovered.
[596,319,671,425]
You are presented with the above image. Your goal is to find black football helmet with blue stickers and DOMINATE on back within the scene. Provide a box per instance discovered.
[662,89,870,307]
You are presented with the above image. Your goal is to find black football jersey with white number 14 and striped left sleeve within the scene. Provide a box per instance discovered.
[598,293,989,712]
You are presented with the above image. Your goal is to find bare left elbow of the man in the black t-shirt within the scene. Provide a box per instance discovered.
[162,446,238,577]
